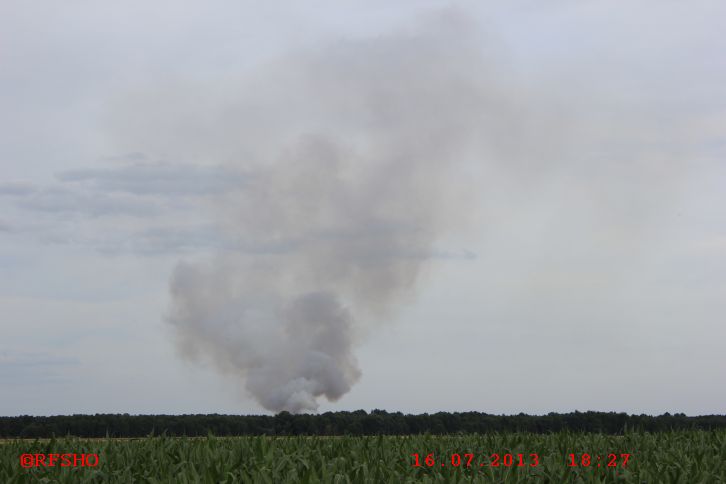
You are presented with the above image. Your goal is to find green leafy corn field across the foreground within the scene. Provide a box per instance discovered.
[0,431,726,484]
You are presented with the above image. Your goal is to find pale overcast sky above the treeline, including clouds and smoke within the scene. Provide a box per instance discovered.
[0,0,726,415]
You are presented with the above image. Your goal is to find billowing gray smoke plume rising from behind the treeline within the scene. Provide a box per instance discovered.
[168,14,505,412]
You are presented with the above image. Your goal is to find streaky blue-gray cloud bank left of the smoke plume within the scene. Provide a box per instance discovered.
[0,163,250,256]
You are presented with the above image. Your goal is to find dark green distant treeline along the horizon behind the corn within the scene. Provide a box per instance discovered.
[0,410,726,438]
